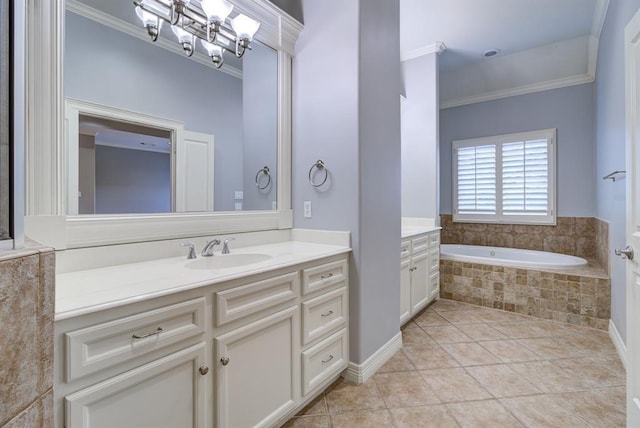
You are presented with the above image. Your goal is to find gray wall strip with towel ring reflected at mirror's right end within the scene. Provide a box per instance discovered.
[239,45,278,210]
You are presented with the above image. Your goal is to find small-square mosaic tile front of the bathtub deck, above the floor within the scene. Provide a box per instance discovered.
[440,260,611,330]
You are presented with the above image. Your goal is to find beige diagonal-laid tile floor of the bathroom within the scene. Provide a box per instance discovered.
[285,299,625,428]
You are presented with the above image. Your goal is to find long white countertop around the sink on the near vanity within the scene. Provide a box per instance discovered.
[55,241,351,321]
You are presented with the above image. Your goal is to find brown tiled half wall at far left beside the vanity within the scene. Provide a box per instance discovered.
[0,247,55,428]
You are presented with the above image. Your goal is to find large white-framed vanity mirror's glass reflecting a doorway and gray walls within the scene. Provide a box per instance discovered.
[64,0,279,215]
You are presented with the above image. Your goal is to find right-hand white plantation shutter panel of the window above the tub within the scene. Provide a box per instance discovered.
[502,139,549,216]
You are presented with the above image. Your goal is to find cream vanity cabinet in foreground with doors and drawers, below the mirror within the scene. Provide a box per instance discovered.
[54,254,349,428]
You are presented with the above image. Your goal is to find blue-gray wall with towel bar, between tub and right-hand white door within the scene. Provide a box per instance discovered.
[595,0,640,340]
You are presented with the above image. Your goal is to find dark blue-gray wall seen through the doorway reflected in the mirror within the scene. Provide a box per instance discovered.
[96,145,171,214]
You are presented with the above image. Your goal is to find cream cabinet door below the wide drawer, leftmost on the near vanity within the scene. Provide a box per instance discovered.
[65,343,206,428]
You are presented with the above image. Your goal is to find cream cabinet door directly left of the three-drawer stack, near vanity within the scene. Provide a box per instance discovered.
[214,306,300,427]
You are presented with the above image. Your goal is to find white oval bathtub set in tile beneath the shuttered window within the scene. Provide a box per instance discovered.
[440,244,588,269]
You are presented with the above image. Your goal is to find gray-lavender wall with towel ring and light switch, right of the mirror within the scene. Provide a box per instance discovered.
[292,0,400,363]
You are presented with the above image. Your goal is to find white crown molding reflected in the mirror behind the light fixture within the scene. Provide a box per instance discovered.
[65,0,242,79]
